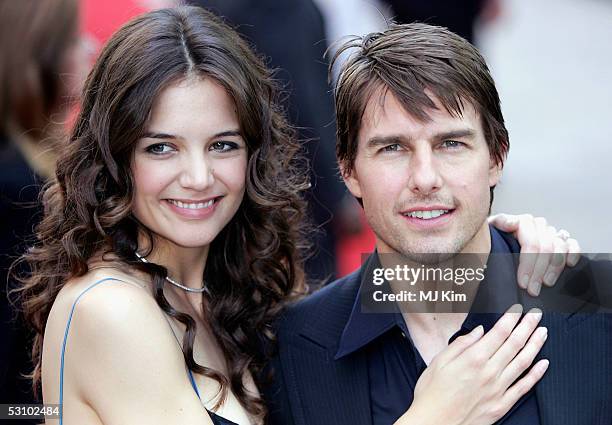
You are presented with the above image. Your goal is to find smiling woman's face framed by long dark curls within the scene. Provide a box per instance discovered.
[132,78,247,248]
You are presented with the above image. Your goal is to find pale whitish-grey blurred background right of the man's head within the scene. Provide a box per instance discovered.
[476,0,612,253]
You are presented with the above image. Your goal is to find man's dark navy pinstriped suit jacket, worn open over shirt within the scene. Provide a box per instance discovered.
[264,235,612,425]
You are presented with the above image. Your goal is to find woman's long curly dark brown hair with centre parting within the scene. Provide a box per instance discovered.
[13,6,308,418]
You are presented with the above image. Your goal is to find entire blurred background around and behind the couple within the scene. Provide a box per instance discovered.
[0,0,612,410]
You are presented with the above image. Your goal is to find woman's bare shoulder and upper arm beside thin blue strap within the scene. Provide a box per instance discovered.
[43,269,213,424]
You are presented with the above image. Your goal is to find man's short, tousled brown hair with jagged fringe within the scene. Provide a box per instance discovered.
[332,23,509,175]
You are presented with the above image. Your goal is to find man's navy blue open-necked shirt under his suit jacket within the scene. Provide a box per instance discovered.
[336,227,540,425]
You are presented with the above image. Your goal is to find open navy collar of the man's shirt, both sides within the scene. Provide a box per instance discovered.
[334,226,518,360]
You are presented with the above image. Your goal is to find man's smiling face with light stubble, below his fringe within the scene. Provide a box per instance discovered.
[343,90,501,262]
